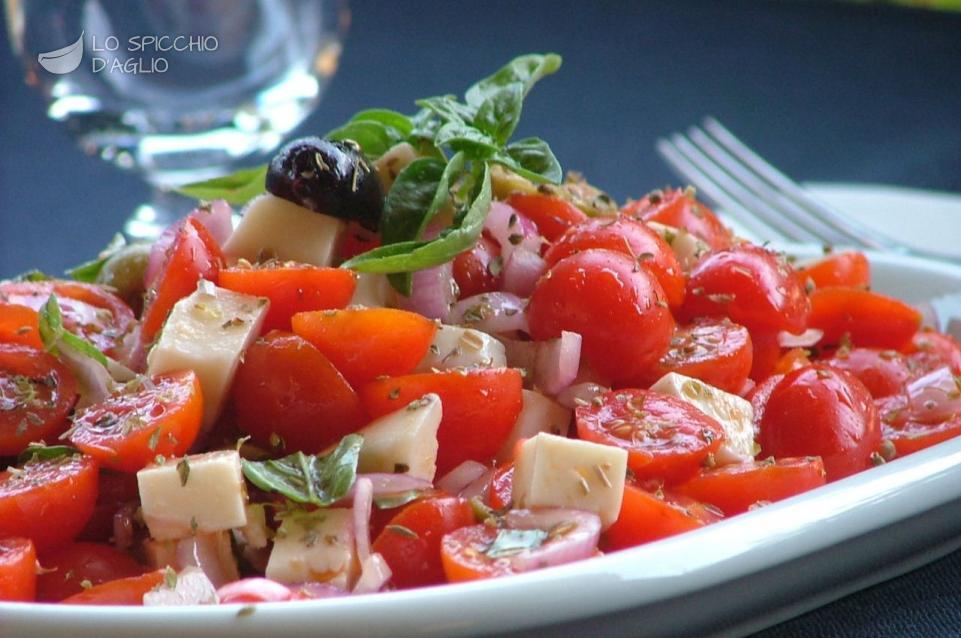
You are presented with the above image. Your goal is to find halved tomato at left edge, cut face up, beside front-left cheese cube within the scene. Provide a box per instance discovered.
[0,455,98,551]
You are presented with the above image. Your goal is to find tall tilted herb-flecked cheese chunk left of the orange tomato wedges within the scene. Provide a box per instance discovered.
[147,281,268,430]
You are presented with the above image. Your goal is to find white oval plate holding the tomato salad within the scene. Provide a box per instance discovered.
[0,248,961,638]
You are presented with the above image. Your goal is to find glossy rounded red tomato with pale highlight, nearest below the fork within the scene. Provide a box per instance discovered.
[681,244,810,334]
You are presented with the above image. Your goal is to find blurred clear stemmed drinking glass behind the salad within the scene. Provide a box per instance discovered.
[6,0,349,238]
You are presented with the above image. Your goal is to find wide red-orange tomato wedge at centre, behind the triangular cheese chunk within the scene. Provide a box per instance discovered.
[361,368,523,476]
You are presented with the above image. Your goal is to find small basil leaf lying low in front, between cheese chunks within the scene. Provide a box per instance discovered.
[243,434,364,507]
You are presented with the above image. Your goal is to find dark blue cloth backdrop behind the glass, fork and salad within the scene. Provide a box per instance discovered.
[0,0,961,637]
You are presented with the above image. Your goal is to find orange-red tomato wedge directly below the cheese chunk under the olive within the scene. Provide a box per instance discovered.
[219,262,357,334]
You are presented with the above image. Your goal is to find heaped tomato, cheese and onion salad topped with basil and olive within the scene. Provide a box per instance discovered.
[0,54,961,612]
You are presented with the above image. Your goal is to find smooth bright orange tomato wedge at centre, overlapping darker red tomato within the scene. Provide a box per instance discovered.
[292,308,437,388]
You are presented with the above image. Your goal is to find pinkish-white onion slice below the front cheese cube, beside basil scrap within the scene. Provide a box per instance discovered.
[505,509,601,572]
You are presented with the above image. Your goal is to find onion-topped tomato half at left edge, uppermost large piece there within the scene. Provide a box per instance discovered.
[0,281,134,356]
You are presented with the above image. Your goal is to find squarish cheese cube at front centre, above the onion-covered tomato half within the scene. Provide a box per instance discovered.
[513,432,627,529]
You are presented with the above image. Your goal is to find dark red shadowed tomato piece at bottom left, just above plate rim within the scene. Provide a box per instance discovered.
[37,543,144,602]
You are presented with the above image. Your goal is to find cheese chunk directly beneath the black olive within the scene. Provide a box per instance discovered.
[224,193,347,266]
